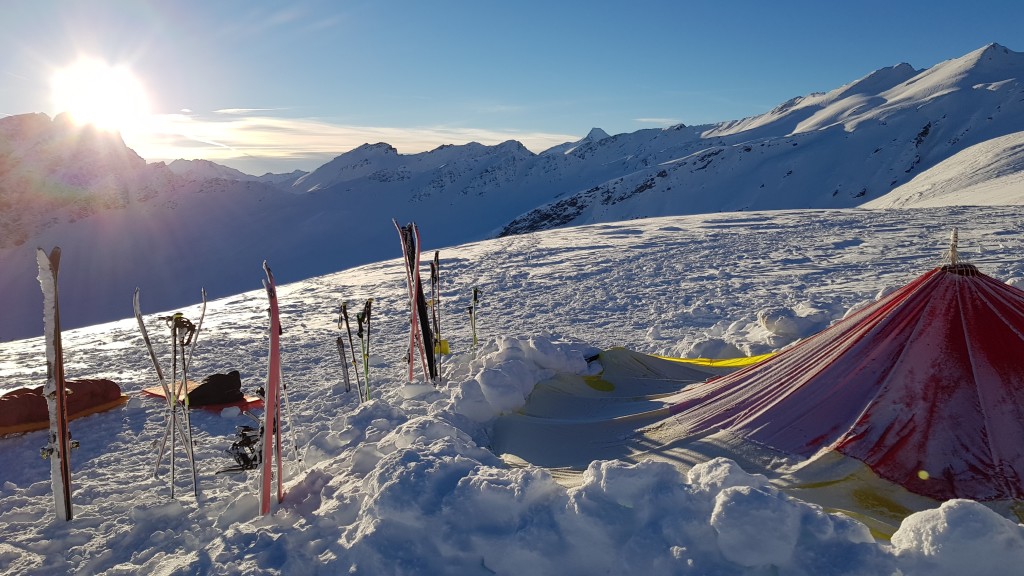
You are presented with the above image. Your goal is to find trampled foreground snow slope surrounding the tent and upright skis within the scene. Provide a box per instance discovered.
[0,207,1024,576]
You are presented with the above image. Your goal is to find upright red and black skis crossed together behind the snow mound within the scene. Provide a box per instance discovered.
[391,218,438,385]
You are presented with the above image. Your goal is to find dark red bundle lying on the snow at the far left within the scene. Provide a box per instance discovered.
[0,379,128,436]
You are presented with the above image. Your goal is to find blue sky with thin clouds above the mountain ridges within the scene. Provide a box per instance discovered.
[0,0,1024,173]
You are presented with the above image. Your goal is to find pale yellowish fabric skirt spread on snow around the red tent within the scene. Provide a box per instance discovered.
[492,348,939,538]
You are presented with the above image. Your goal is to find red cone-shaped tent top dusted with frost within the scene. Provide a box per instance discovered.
[670,260,1024,500]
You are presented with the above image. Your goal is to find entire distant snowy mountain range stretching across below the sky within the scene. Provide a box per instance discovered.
[0,44,1024,339]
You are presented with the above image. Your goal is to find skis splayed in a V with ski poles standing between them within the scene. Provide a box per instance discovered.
[132,288,206,498]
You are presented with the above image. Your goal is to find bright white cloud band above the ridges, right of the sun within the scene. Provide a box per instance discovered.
[123,109,579,169]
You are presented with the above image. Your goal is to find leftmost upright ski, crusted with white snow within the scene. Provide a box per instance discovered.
[36,247,73,521]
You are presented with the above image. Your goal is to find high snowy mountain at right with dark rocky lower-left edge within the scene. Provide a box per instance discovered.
[502,44,1024,235]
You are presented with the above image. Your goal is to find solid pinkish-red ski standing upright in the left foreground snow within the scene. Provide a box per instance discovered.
[259,261,285,516]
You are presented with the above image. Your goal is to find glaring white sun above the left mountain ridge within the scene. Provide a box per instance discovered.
[50,57,148,132]
